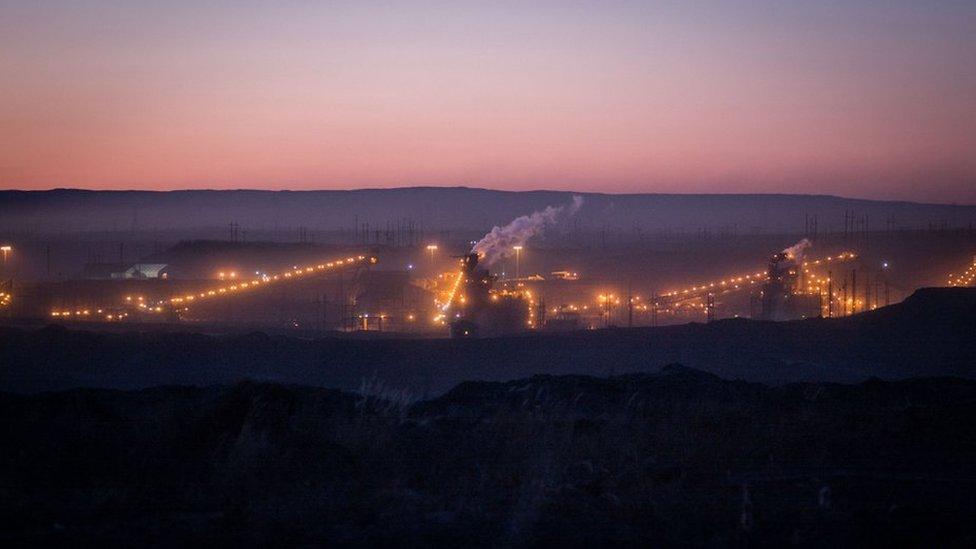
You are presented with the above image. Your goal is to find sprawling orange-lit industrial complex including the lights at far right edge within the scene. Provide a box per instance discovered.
[0,222,964,338]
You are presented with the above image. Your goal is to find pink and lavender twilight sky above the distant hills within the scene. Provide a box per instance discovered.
[0,0,976,204]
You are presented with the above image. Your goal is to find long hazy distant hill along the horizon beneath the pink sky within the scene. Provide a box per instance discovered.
[0,187,976,233]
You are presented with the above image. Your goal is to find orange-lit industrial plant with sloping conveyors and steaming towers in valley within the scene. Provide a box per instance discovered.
[0,237,912,337]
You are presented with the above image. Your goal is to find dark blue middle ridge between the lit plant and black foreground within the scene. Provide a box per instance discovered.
[0,288,976,398]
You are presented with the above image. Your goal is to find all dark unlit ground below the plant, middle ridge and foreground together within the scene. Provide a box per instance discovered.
[0,289,976,546]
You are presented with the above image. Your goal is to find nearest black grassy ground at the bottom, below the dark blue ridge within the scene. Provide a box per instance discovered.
[0,366,976,546]
